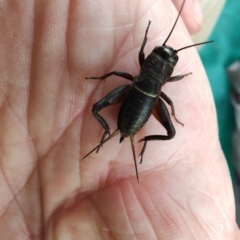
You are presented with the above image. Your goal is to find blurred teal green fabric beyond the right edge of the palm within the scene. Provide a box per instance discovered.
[200,0,240,180]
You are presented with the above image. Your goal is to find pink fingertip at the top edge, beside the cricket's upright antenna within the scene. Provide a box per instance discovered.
[172,0,203,33]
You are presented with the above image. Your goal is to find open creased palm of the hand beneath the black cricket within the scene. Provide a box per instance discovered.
[0,0,240,240]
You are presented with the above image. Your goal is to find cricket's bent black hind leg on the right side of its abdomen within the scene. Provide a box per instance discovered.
[139,98,176,163]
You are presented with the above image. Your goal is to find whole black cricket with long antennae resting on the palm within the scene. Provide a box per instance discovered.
[81,0,213,181]
